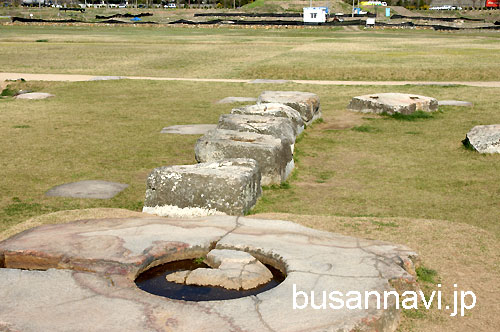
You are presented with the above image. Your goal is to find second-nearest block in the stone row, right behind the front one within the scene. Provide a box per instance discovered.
[195,129,294,185]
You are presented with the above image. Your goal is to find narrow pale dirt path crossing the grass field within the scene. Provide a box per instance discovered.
[0,73,500,88]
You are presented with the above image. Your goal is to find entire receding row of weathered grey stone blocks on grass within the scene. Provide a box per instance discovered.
[143,91,321,216]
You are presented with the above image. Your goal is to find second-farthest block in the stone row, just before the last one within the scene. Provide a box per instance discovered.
[231,103,304,136]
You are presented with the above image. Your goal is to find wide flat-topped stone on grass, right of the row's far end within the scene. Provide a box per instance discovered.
[347,93,438,115]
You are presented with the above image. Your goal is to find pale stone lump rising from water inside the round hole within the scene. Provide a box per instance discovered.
[167,249,273,290]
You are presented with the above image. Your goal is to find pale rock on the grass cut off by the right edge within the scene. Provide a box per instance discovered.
[462,124,500,153]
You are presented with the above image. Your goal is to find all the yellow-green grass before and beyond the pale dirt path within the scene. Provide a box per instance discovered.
[0,26,500,331]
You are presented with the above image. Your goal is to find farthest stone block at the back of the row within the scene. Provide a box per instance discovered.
[257,91,321,124]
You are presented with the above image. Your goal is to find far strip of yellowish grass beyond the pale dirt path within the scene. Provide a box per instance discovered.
[0,25,500,81]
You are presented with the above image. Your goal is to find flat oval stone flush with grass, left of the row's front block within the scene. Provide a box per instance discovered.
[45,180,128,199]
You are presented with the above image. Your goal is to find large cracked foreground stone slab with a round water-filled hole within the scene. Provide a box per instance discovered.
[0,216,416,332]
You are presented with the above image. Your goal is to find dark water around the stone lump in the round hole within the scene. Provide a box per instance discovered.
[135,253,286,301]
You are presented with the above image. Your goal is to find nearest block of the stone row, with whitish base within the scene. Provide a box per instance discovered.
[143,158,261,217]
